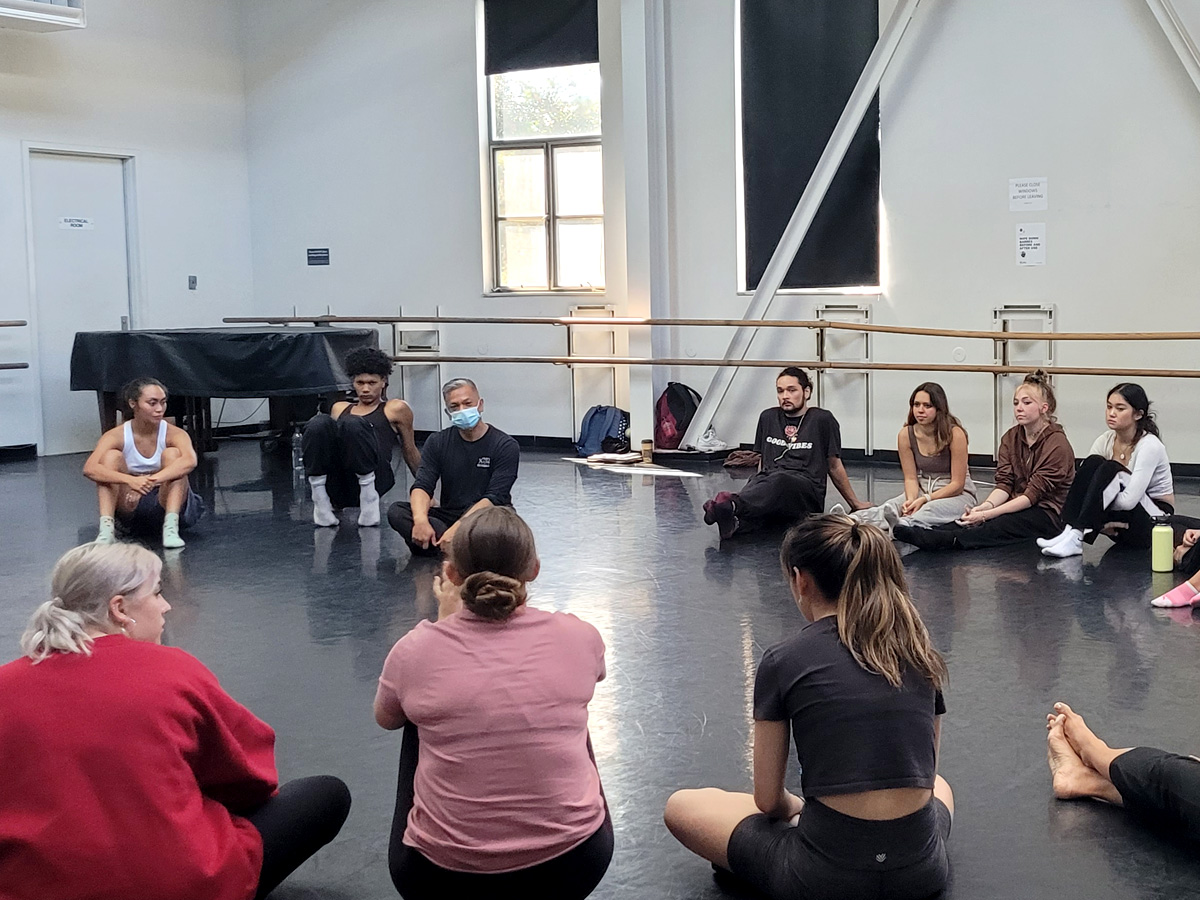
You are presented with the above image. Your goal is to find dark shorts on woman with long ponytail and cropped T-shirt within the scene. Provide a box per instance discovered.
[727,797,950,900]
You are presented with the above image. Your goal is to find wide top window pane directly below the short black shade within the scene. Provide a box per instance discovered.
[488,62,600,140]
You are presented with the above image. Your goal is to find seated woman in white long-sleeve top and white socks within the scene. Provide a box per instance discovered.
[1038,383,1175,557]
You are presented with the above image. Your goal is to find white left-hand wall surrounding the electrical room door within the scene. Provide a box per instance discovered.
[0,0,251,446]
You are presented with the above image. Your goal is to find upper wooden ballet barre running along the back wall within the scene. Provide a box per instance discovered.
[221,316,1200,342]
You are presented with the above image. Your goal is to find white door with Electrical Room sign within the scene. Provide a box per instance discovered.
[29,154,130,455]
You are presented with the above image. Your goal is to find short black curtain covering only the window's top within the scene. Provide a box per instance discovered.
[484,0,600,74]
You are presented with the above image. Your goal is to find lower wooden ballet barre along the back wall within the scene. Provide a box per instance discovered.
[391,353,1200,378]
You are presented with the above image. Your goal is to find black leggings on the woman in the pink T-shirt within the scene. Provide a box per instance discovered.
[388,725,613,900]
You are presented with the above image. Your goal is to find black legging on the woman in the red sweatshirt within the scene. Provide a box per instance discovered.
[246,775,350,900]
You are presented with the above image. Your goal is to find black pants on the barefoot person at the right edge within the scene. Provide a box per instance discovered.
[1109,746,1200,841]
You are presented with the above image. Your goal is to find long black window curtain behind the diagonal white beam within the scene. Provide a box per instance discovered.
[742,0,880,290]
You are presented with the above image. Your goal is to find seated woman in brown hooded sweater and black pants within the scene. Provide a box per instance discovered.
[893,370,1075,550]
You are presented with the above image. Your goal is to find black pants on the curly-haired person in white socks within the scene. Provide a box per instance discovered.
[300,413,396,509]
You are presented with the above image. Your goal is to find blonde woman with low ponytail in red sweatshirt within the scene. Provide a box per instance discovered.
[0,544,350,900]
